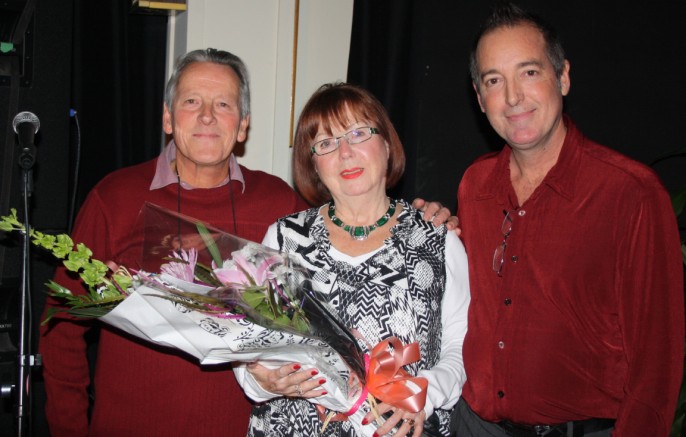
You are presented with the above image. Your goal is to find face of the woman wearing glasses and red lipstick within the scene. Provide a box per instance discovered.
[312,113,389,202]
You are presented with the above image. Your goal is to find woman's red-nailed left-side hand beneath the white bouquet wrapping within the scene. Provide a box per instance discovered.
[246,362,326,399]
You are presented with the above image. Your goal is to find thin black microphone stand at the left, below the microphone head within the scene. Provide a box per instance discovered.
[15,144,40,437]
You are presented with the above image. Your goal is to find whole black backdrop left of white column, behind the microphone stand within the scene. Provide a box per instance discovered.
[0,0,168,437]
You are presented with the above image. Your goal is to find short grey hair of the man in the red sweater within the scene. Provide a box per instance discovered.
[164,49,250,120]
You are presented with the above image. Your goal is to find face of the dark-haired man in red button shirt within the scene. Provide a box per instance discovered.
[475,25,570,150]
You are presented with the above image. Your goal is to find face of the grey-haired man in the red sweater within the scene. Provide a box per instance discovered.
[163,62,249,176]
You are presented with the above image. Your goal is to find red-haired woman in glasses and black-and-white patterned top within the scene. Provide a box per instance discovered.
[236,83,469,437]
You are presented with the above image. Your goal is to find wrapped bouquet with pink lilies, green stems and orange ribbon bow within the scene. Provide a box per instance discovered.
[0,204,426,426]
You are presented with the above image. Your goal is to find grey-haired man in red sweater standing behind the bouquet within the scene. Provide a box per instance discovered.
[39,49,307,437]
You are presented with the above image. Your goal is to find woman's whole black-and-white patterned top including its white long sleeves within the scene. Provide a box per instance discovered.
[235,200,469,437]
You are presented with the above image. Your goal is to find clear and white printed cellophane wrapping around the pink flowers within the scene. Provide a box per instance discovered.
[100,204,365,412]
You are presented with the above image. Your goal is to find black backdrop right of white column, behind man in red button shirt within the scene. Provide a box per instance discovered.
[348,0,686,215]
